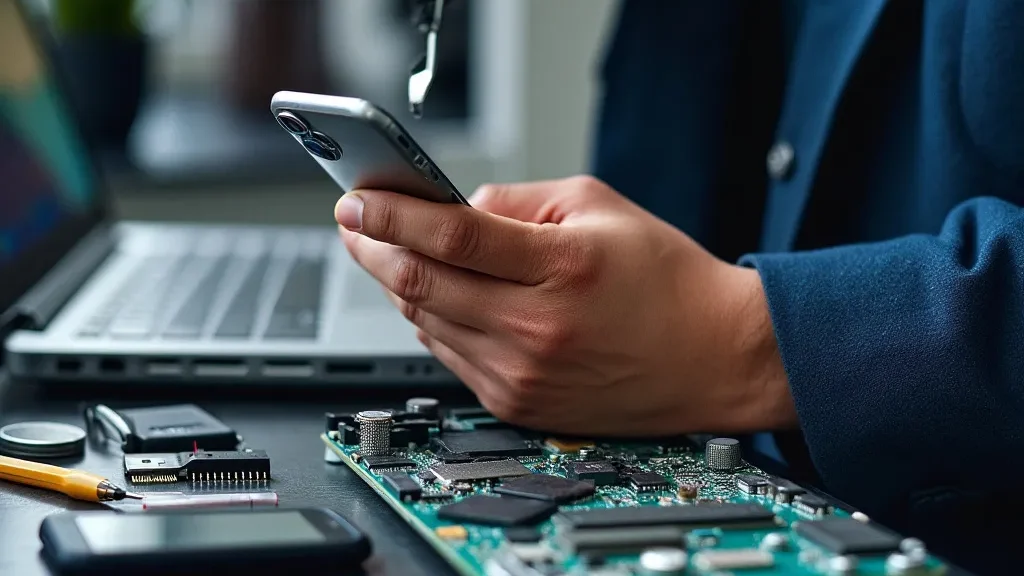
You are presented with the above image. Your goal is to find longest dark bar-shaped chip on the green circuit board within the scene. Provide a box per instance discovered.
[555,502,775,530]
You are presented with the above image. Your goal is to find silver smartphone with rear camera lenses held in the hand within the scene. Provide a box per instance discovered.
[270,92,469,206]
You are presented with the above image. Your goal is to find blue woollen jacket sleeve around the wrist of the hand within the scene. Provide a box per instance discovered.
[740,198,1024,541]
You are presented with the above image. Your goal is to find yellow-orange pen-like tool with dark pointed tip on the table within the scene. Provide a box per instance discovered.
[0,456,142,502]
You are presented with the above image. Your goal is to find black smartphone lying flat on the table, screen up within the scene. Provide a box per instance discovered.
[39,508,371,575]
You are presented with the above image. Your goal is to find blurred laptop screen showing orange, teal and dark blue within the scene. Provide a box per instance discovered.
[0,0,98,312]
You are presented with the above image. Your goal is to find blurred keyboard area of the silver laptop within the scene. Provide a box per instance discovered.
[79,238,327,340]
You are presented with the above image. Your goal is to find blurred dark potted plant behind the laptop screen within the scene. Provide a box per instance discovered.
[50,0,147,148]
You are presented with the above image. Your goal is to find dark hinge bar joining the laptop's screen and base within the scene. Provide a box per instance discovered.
[0,224,117,334]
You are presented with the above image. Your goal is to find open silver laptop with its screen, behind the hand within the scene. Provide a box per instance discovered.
[0,0,456,384]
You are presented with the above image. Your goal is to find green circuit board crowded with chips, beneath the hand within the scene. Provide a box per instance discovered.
[322,399,946,576]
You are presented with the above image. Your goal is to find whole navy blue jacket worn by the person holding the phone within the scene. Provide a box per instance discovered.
[594,0,1024,572]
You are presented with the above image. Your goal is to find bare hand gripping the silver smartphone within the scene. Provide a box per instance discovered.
[335,176,796,436]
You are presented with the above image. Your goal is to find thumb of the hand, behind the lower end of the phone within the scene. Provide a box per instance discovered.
[469,176,610,224]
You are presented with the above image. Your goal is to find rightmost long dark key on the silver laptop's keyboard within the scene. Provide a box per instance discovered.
[263,258,325,339]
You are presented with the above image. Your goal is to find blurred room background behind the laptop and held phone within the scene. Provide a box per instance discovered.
[22,0,616,223]
